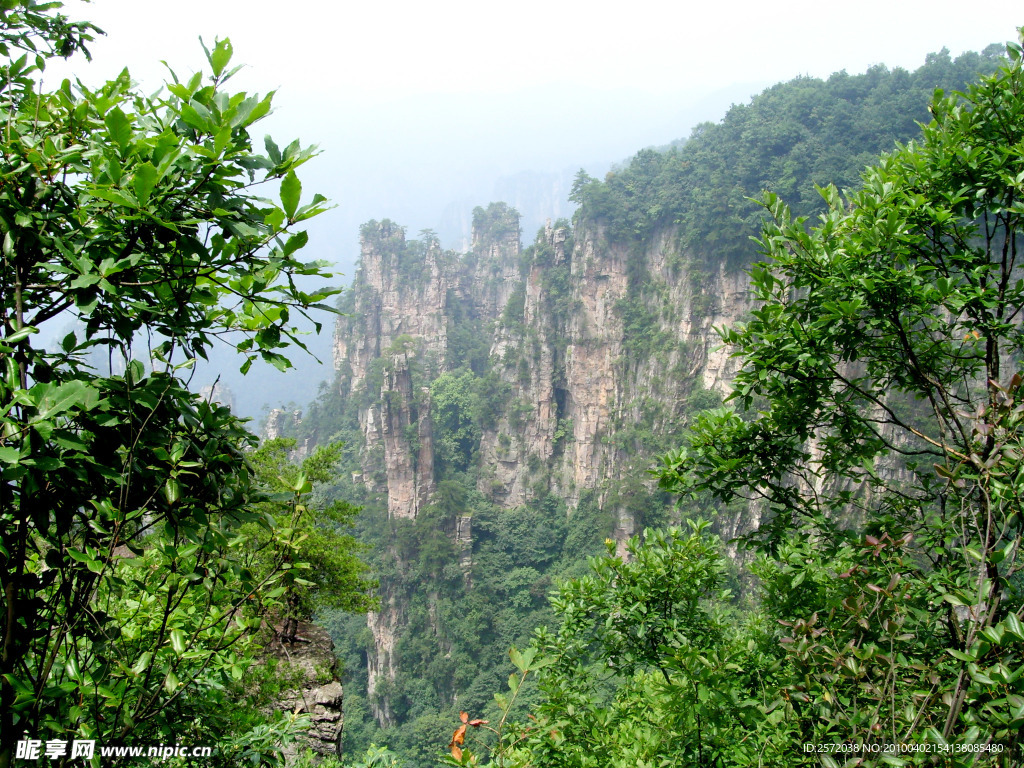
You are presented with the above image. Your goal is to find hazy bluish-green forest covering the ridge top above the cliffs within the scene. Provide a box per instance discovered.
[571,46,1001,264]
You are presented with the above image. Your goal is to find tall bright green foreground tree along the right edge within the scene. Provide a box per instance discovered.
[663,31,1024,765]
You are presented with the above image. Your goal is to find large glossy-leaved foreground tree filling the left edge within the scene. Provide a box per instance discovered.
[0,0,344,766]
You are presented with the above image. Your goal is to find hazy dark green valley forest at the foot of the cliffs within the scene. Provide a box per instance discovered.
[321,481,611,768]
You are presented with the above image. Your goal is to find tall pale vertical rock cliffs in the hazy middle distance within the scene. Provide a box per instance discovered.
[327,204,753,725]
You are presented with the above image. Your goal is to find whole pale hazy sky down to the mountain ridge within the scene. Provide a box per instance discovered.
[50,0,1024,417]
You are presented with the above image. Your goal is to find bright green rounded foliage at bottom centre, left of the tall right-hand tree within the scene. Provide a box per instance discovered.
[449,523,779,768]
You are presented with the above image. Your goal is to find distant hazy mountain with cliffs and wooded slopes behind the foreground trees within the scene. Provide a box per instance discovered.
[282,47,1005,766]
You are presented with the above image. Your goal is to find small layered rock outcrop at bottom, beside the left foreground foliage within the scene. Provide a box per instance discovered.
[265,623,344,762]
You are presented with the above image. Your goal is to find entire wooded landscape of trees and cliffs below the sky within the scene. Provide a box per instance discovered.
[0,0,1024,768]
